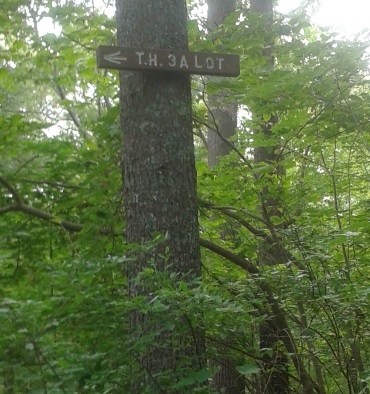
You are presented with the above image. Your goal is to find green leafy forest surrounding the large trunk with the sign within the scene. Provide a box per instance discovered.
[0,0,370,394]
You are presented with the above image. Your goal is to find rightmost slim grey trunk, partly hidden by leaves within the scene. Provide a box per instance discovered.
[250,0,325,394]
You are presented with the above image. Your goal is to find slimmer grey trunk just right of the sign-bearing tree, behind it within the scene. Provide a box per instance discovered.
[207,0,238,167]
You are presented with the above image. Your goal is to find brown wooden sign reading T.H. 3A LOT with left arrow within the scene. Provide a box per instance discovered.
[96,46,240,77]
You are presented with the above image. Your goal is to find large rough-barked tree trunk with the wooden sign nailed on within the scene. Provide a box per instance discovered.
[117,0,204,393]
